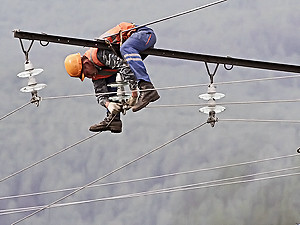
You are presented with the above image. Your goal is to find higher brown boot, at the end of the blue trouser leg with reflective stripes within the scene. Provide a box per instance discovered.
[132,80,160,112]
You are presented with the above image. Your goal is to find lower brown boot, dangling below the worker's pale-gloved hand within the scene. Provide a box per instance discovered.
[90,114,122,133]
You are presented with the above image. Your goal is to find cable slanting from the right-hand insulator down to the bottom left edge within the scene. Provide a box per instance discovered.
[11,122,207,225]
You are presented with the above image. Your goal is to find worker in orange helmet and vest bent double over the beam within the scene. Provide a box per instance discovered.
[65,22,159,133]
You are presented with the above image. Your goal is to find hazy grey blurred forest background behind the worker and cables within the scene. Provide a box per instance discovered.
[0,0,300,225]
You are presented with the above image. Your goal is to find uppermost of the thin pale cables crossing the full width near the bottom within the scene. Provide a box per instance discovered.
[0,154,300,200]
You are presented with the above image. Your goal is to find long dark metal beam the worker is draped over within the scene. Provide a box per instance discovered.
[14,30,300,73]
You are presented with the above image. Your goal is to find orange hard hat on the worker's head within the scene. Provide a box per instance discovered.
[65,53,84,81]
